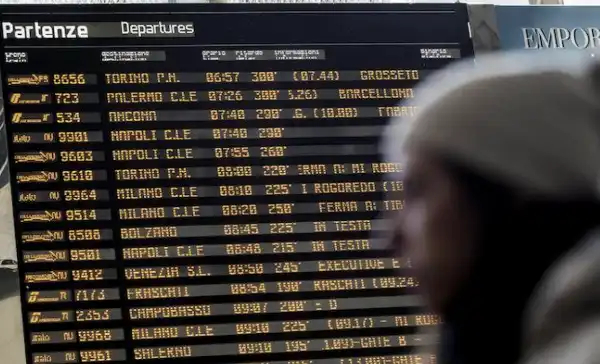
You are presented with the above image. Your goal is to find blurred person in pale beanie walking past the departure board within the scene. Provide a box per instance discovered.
[383,54,600,364]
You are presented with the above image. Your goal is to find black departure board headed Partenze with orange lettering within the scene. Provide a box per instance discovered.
[1,4,472,364]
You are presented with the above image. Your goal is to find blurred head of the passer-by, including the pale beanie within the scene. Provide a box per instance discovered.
[384,51,600,313]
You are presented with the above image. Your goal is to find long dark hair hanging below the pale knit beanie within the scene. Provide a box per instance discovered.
[440,161,600,364]
